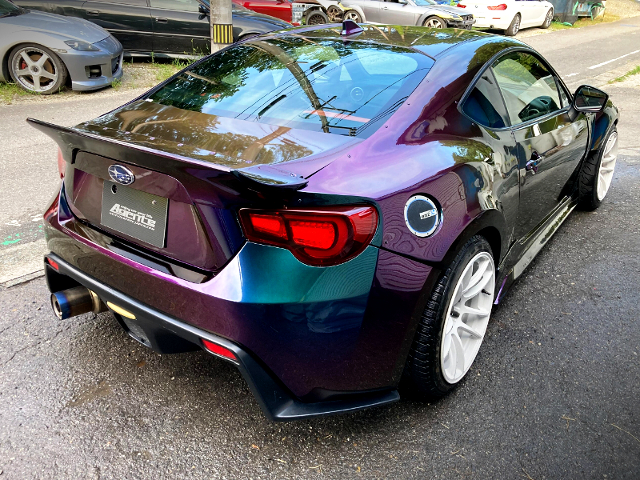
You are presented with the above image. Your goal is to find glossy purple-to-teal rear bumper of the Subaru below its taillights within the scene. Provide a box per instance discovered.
[44,189,438,419]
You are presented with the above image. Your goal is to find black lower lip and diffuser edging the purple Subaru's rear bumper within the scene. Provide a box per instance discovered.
[45,253,400,420]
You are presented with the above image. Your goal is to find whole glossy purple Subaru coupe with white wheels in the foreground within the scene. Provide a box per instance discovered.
[30,21,618,420]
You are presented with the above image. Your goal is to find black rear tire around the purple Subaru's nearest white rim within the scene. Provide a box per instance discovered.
[402,235,493,400]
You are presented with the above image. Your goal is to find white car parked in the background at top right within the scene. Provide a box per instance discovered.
[458,0,553,36]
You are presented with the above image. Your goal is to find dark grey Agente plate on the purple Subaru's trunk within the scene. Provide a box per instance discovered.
[100,180,169,248]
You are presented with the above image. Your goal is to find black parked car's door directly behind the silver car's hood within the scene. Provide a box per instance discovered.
[82,0,153,52]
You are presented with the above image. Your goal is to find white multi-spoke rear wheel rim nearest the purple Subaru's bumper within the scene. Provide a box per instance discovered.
[440,252,496,384]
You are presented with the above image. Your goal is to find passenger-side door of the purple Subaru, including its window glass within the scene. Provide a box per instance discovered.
[491,52,589,244]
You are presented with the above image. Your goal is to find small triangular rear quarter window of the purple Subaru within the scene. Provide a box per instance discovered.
[462,71,507,128]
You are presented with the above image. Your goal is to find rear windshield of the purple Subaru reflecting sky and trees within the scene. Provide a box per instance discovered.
[150,36,433,136]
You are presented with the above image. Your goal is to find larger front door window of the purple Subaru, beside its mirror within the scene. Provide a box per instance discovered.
[492,52,561,125]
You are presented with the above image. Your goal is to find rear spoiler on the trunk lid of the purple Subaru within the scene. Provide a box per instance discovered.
[27,118,308,190]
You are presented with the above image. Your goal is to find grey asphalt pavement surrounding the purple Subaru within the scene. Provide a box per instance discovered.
[0,19,640,480]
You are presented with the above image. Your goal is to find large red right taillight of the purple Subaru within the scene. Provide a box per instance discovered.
[240,206,378,266]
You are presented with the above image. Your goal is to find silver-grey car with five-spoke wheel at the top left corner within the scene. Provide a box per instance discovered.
[0,0,122,94]
